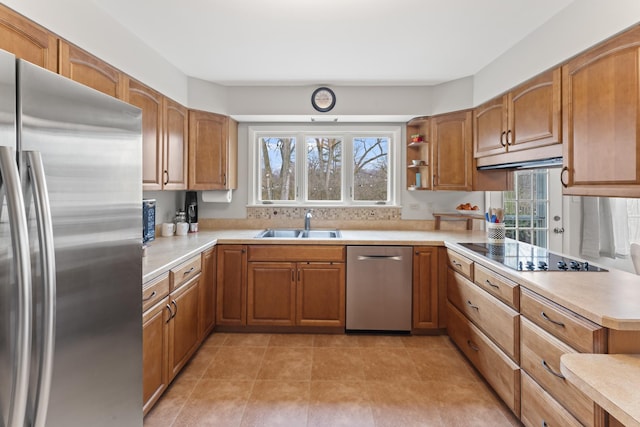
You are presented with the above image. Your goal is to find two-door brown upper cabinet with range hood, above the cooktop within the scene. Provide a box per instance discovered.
[473,68,562,166]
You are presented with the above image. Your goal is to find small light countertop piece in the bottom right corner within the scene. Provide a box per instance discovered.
[560,353,640,427]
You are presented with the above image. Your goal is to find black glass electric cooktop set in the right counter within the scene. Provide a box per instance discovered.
[460,239,607,272]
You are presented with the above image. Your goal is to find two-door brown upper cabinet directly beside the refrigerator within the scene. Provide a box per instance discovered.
[126,79,188,191]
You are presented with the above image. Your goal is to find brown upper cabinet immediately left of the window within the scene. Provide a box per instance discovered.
[189,110,238,190]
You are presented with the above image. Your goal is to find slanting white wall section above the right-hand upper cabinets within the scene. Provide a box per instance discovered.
[473,0,640,105]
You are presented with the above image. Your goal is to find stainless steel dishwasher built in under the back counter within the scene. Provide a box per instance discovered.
[346,246,413,331]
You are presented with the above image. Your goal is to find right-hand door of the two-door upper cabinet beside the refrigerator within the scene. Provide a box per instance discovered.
[162,98,189,190]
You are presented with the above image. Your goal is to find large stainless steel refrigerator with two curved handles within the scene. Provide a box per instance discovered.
[0,51,142,427]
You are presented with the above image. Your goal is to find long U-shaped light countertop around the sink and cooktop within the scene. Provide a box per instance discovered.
[142,229,640,330]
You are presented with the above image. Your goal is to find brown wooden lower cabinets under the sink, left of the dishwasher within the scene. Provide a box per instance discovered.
[216,245,345,327]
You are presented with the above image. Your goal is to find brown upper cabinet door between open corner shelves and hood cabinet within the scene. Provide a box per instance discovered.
[431,111,473,191]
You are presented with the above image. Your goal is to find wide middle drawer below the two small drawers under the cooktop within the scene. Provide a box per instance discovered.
[447,270,520,362]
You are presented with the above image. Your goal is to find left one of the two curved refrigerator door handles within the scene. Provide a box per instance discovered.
[0,147,32,426]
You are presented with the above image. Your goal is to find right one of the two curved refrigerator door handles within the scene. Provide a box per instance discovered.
[24,150,56,427]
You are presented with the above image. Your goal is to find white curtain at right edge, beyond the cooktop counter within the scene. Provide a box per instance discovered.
[580,197,640,258]
